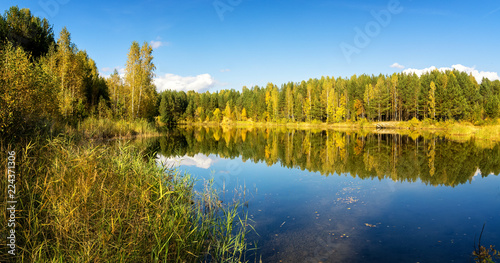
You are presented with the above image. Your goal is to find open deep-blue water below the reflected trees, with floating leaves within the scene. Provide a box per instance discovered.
[159,154,500,262]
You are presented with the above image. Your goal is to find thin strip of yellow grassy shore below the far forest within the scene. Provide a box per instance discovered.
[180,119,500,141]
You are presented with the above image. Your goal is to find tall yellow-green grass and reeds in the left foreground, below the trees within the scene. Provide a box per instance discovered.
[0,136,250,262]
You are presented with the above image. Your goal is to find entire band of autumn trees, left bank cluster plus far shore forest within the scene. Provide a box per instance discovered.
[0,7,500,138]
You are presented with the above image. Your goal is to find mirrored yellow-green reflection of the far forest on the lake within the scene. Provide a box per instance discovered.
[153,127,500,187]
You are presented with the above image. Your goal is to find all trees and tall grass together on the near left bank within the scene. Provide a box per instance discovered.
[0,7,247,262]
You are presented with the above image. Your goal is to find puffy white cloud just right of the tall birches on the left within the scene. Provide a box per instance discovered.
[153,73,215,92]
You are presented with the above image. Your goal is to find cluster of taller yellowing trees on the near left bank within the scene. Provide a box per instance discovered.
[0,6,158,134]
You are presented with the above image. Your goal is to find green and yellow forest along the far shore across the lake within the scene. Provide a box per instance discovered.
[160,70,500,123]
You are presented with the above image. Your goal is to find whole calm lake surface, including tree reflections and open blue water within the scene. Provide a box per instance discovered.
[148,127,500,262]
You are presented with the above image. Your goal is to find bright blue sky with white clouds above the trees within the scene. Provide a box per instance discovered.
[0,0,500,91]
